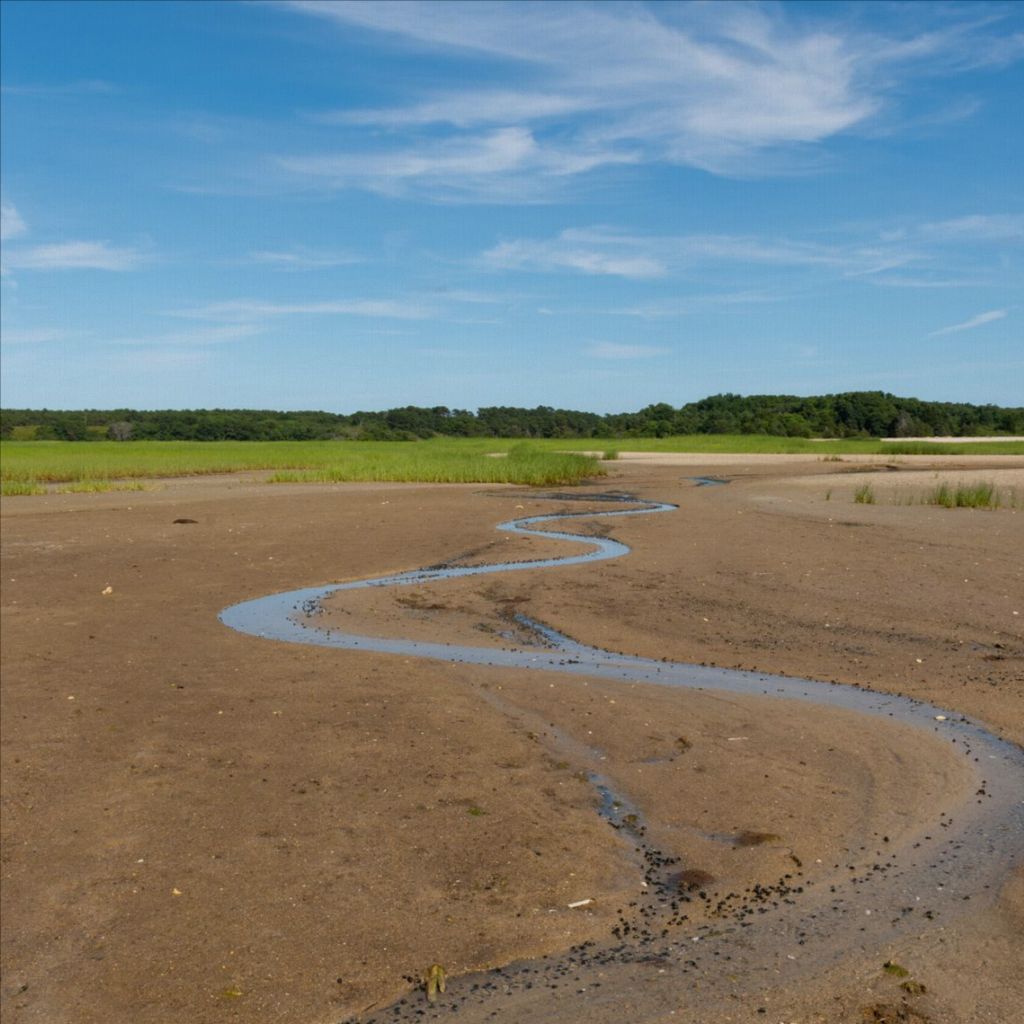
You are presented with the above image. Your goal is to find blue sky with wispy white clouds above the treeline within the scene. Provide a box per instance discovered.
[0,0,1024,412]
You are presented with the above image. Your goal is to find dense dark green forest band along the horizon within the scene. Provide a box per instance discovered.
[0,391,1024,441]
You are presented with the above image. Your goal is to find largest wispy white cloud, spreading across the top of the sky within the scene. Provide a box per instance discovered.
[282,0,1022,201]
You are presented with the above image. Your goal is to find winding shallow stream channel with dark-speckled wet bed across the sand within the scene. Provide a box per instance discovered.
[220,495,1024,1024]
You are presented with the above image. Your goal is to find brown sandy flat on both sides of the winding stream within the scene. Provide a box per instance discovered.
[2,457,1024,1024]
